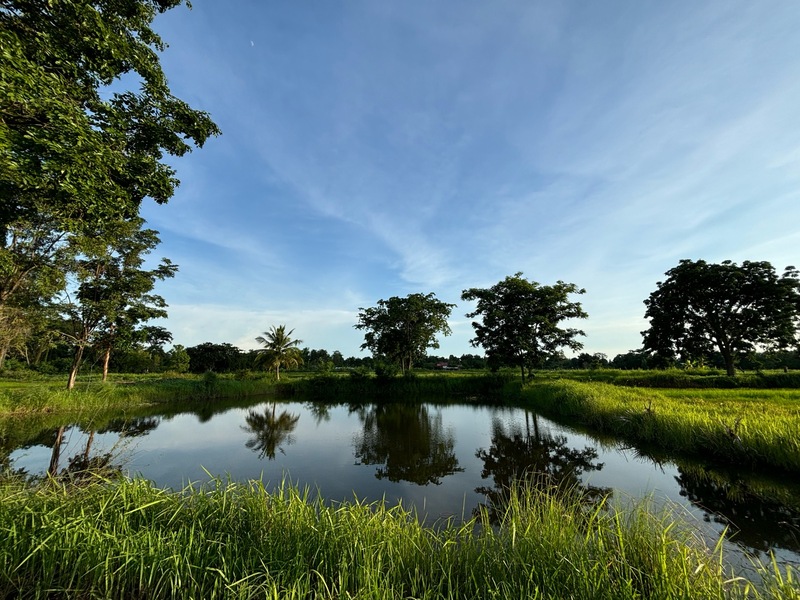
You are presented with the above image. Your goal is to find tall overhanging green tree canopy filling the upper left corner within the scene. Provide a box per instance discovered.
[0,0,219,332]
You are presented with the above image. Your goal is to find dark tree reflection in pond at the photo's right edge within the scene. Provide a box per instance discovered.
[675,465,800,556]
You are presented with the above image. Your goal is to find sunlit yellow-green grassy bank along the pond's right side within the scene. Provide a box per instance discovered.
[523,380,800,473]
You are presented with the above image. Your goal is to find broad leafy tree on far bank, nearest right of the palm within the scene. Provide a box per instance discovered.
[355,292,455,373]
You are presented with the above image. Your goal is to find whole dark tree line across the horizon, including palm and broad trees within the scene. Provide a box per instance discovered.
[3,260,800,378]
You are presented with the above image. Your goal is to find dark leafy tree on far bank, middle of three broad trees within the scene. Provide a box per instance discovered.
[461,273,588,381]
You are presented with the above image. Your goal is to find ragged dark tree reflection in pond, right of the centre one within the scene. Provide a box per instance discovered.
[474,411,611,523]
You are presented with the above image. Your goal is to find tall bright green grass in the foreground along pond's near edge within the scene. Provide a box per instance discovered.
[0,481,799,600]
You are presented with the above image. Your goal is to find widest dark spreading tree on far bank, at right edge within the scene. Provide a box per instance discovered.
[642,260,800,376]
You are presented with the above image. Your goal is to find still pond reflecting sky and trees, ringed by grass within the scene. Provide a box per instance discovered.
[3,402,800,568]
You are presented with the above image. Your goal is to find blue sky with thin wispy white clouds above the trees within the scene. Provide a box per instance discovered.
[138,0,800,358]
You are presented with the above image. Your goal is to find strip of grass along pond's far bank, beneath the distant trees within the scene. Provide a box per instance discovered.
[0,369,800,413]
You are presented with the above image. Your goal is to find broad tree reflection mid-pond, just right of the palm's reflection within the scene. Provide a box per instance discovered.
[354,404,464,485]
